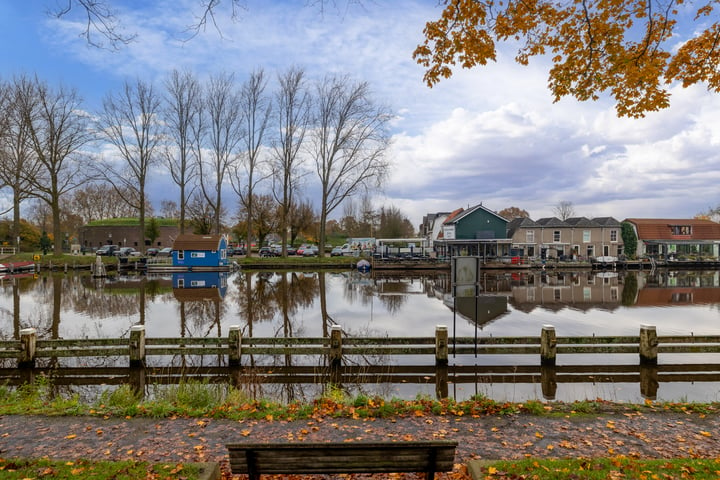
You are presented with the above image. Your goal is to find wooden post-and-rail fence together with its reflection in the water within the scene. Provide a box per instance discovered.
[0,325,720,399]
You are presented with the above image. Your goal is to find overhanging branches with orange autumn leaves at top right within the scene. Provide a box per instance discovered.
[413,0,720,117]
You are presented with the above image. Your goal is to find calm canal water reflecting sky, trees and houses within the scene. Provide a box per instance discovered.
[0,271,720,402]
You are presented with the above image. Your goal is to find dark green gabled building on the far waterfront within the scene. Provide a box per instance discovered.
[434,205,510,257]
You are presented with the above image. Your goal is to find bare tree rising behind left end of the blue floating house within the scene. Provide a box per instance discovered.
[163,70,202,233]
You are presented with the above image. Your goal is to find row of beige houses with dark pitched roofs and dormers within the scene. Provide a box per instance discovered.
[508,217,623,258]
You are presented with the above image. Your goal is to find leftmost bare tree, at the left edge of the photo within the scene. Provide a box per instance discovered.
[0,76,40,248]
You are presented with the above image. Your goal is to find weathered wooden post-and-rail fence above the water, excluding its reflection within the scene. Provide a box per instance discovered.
[0,325,720,368]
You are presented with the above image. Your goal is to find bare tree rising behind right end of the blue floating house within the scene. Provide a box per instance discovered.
[195,73,244,233]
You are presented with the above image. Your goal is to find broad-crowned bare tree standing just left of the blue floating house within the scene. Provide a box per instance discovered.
[98,79,161,251]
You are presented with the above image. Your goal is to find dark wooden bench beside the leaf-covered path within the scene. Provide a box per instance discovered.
[226,440,457,480]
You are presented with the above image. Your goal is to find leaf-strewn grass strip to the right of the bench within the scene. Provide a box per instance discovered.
[480,456,720,480]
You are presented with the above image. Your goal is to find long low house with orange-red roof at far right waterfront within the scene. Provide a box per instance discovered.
[625,218,720,257]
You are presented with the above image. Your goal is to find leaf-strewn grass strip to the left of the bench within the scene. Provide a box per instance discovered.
[0,459,210,480]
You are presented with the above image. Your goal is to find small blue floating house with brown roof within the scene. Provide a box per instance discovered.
[172,234,228,269]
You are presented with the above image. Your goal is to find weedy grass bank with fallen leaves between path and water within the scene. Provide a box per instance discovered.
[0,377,720,420]
